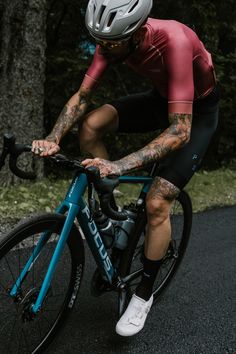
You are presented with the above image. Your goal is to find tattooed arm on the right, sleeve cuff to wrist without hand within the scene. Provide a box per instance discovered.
[116,114,192,174]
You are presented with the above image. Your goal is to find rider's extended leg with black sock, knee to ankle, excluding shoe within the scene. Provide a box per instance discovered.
[136,177,179,301]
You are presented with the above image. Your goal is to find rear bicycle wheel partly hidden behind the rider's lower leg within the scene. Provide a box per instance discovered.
[119,191,192,308]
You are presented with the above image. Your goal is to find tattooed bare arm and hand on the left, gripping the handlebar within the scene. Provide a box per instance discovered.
[32,86,91,156]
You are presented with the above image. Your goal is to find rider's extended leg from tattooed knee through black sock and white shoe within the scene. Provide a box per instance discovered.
[116,177,179,336]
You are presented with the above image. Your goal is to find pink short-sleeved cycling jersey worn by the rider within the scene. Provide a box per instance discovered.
[82,18,215,114]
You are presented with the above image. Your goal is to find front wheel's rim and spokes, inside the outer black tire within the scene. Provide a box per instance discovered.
[0,221,76,354]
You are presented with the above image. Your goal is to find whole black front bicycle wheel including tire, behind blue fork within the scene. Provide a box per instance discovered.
[0,214,84,354]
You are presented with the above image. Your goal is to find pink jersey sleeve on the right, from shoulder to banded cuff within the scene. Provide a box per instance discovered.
[165,36,194,114]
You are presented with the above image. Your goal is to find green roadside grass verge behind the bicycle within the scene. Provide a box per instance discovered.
[0,169,236,219]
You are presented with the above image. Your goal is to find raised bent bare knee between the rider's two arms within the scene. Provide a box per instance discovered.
[79,104,119,159]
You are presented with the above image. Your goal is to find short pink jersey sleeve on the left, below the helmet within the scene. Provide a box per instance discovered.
[82,46,109,89]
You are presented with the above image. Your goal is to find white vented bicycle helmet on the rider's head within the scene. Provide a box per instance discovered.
[85,0,153,40]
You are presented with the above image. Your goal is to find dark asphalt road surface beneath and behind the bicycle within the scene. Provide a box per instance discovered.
[0,207,236,354]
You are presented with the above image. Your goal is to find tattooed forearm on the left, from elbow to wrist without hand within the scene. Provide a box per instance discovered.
[46,91,89,144]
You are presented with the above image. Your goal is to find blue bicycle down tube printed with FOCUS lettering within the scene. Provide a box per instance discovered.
[78,199,115,284]
